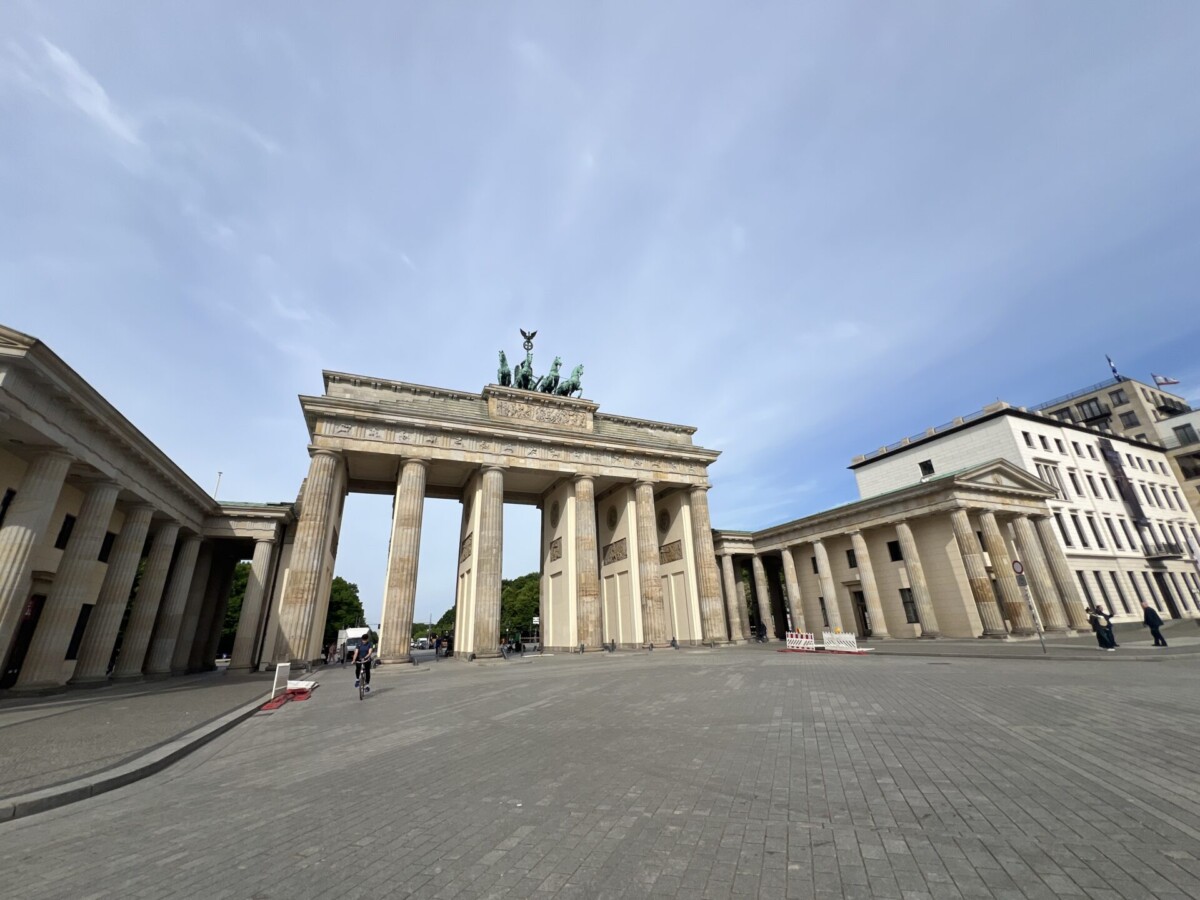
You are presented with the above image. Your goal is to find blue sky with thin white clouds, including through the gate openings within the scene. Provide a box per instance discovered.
[0,0,1200,622]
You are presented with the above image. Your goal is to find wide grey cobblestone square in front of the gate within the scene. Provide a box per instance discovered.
[0,648,1200,900]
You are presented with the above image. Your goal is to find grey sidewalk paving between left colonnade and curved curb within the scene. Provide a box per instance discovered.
[0,672,271,797]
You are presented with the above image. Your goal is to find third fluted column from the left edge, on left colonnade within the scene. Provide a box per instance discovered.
[71,504,154,684]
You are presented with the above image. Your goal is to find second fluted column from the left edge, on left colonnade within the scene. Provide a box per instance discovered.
[16,481,120,690]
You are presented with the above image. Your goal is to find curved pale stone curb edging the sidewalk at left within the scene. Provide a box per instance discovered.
[0,694,271,822]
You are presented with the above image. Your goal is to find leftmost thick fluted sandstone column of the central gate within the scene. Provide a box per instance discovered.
[274,446,342,662]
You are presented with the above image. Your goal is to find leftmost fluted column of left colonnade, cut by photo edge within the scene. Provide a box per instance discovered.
[0,450,71,662]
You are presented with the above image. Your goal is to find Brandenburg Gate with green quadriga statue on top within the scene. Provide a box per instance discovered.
[275,332,728,662]
